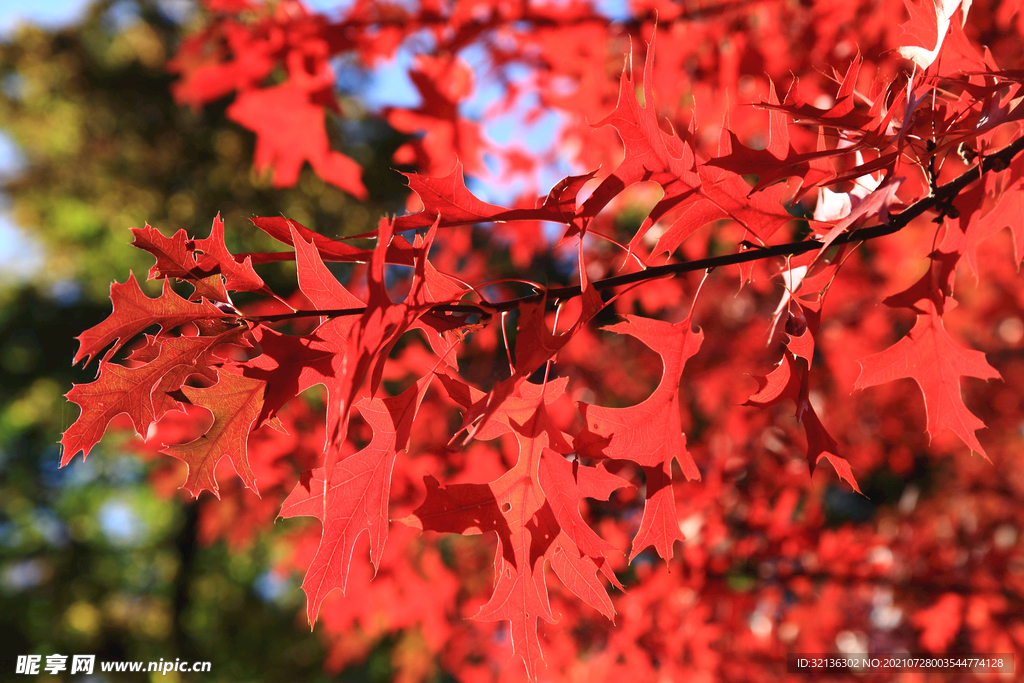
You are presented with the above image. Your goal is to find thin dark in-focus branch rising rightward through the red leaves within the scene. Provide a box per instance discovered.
[241,137,1024,323]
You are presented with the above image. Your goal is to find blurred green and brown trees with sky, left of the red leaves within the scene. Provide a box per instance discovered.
[0,0,415,683]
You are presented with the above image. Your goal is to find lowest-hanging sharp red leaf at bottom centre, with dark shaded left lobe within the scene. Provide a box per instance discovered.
[408,389,625,680]
